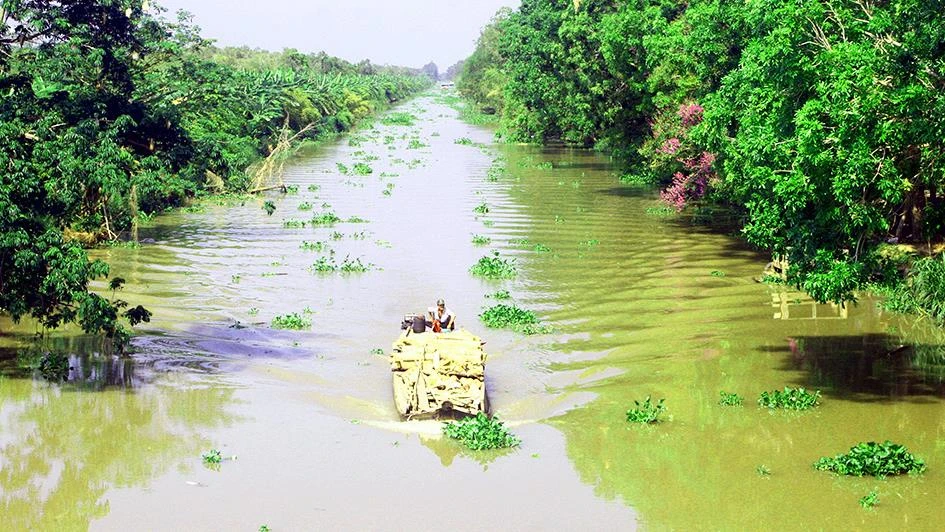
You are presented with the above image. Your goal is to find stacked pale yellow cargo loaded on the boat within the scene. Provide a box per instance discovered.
[390,328,488,419]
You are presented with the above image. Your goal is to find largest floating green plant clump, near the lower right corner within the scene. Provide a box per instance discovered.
[814,440,925,477]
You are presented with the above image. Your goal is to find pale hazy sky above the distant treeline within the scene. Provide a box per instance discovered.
[156,0,520,72]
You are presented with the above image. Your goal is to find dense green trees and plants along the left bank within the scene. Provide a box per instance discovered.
[0,0,430,336]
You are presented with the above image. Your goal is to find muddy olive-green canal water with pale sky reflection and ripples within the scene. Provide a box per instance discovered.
[0,93,945,530]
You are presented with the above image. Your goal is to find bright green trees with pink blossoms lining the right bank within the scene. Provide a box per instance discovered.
[458,0,945,301]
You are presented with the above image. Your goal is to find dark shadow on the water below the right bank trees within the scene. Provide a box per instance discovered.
[759,334,945,402]
